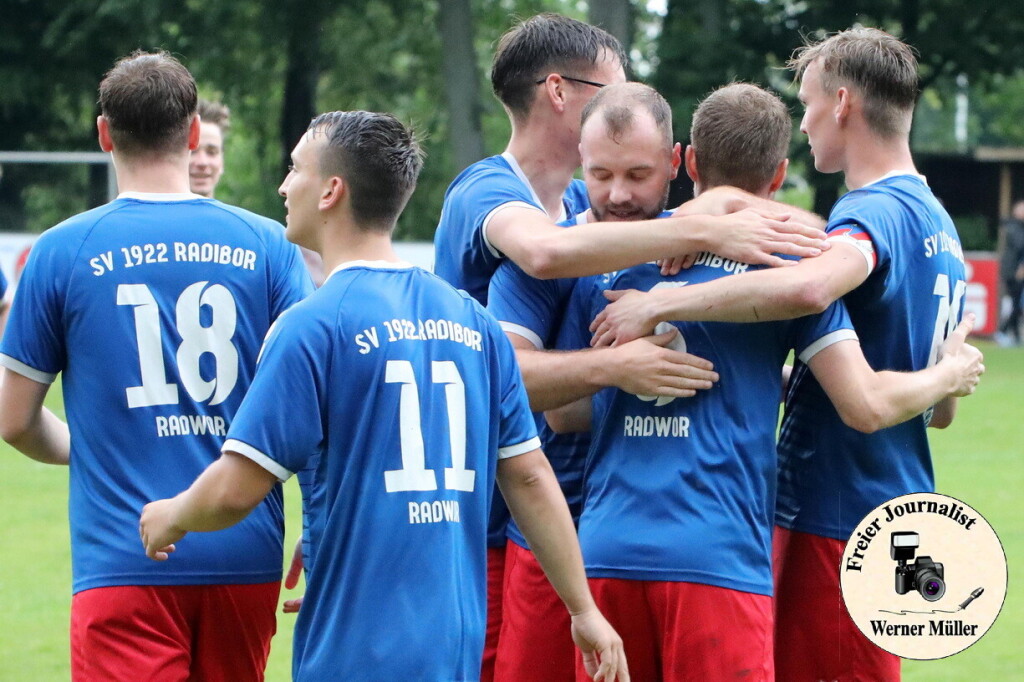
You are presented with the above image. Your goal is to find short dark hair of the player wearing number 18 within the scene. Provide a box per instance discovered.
[99,50,198,154]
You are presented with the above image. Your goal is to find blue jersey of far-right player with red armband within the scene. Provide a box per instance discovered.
[777,174,967,540]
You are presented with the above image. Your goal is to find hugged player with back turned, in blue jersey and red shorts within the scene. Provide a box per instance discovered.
[552,84,980,681]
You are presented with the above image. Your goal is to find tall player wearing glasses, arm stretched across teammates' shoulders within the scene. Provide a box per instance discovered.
[434,13,827,680]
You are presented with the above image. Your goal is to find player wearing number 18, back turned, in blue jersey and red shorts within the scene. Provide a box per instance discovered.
[0,52,312,682]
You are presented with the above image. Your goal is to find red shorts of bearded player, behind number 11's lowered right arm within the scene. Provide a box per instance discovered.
[495,541,575,682]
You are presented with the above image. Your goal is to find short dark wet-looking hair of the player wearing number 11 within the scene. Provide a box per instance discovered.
[309,112,423,231]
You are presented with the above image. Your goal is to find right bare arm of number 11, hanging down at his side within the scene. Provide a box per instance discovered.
[497,450,630,682]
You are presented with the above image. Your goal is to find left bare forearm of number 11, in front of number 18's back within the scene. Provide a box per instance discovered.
[138,453,278,561]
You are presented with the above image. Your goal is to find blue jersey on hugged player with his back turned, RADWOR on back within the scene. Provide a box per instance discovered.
[566,253,856,595]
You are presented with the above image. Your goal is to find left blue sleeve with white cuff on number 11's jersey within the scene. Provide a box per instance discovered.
[222,308,332,480]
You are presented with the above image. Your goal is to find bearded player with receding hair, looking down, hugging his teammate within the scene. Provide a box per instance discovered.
[487,83,717,682]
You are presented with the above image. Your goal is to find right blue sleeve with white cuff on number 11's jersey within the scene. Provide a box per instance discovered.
[487,313,541,459]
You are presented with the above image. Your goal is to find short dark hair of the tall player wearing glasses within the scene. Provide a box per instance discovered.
[490,12,628,116]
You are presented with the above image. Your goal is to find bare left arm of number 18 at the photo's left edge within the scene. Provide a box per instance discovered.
[0,369,71,465]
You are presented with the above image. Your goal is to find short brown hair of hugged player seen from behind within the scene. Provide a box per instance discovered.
[690,83,793,194]
